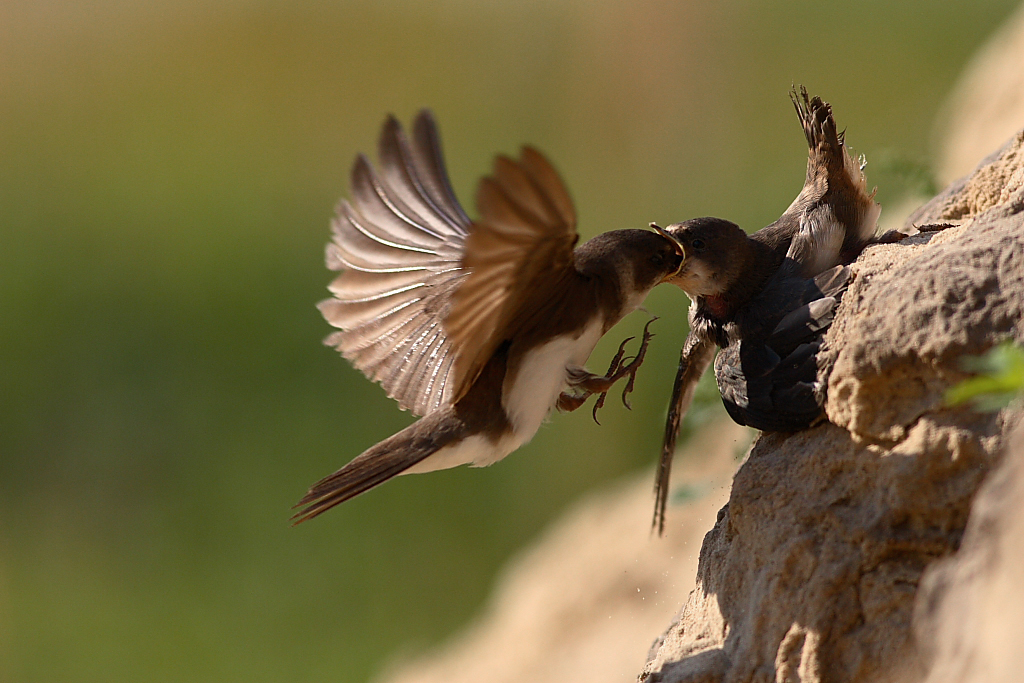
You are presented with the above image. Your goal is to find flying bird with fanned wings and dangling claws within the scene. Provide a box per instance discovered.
[294,111,682,523]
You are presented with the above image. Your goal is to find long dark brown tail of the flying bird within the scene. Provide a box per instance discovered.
[292,408,465,524]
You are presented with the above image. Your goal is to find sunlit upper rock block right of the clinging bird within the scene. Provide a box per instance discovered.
[821,158,1024,443]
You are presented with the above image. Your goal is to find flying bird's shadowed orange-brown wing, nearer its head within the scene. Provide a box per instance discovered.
[444,147,579,400]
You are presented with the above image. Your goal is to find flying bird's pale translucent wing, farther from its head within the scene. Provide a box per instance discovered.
[318,111,470,415]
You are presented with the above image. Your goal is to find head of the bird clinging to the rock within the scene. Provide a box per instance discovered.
[651,217,750,299]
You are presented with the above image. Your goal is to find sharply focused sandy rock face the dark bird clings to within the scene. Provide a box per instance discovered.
[640,134,1024,683]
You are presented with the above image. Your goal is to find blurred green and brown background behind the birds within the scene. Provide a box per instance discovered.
[0,0,1016,683]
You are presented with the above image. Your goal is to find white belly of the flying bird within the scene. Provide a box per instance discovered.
[402,319,604,474]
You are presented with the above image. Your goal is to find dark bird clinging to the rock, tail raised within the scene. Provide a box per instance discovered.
[653,88,895,533]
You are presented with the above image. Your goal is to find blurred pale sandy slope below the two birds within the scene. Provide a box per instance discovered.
[372,421,752,683]
